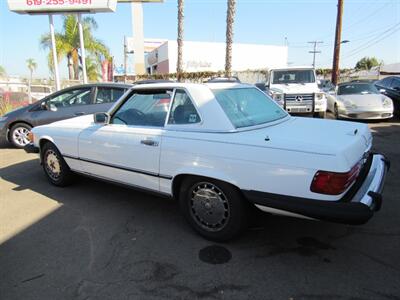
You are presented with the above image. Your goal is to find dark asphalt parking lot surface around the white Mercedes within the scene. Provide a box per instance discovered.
[0,118,400,299]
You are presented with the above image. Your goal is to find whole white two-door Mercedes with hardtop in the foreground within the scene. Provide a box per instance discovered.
[25,82,389,241]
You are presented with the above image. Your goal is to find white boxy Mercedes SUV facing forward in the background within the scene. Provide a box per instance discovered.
[267,67,327,118]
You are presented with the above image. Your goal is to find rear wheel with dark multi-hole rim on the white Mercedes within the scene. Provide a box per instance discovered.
[179,177,249,242]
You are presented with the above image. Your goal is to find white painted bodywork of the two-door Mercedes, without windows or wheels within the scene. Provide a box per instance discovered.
[33,83,384,225]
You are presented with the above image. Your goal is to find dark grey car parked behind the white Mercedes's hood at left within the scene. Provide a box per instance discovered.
[0,83,131,148]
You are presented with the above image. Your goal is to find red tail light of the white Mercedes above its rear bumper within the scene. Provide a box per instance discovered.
[310,163,361,195]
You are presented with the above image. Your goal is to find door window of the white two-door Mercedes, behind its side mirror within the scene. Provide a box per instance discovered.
[111,90,172,127]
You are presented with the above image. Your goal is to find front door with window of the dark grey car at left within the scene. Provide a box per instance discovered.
[31,87,92,126]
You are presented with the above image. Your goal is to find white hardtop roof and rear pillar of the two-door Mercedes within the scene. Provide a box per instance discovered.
[128,82,256,132]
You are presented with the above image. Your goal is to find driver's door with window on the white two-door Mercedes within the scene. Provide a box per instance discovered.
[78,89,172,191]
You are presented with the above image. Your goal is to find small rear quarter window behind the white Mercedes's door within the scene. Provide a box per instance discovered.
[168,90,200,124]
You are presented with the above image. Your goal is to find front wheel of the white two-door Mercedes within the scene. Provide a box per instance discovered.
[41,142,73,186]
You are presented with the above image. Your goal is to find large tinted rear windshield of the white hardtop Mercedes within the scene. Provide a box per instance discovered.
[212,88,287,128]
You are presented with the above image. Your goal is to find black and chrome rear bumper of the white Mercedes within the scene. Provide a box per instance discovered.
[243,154,390,225]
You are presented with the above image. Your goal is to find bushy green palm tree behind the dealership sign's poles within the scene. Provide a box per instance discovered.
[40,15,110,80]
